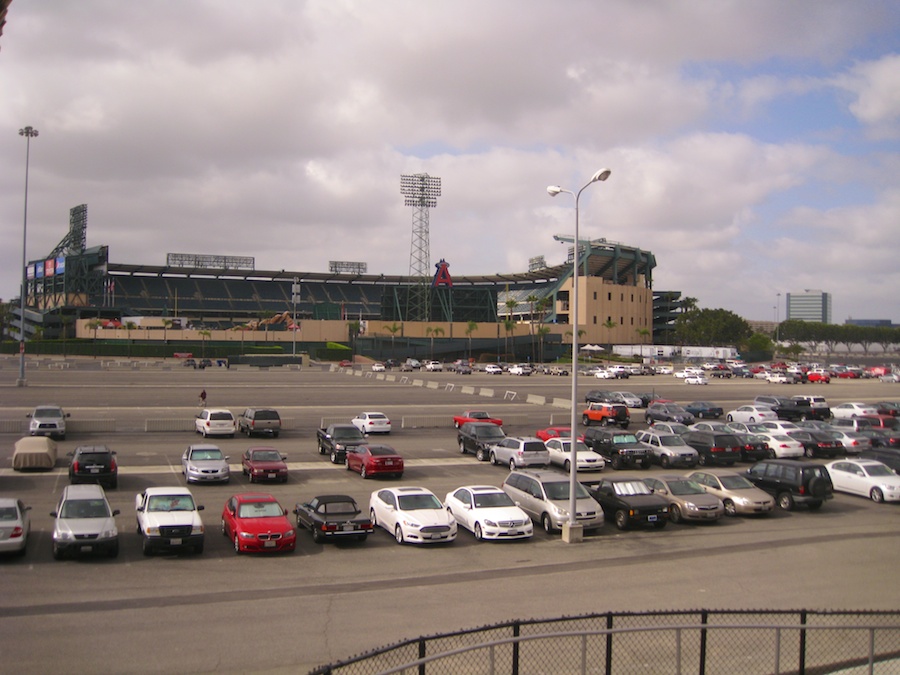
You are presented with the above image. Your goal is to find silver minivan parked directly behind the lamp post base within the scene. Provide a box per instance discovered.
[503,469,603,532]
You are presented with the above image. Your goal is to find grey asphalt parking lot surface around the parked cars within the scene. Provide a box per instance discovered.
[0,362,900,673]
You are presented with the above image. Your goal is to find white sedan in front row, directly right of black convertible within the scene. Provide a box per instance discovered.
[369,487,457,544]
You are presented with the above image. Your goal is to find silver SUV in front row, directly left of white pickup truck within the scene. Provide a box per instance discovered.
[50,484,119,560]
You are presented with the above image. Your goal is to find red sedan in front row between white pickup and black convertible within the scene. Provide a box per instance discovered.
[222,494,297,553]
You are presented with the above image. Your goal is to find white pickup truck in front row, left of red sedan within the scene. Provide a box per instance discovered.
[134,487,204,555]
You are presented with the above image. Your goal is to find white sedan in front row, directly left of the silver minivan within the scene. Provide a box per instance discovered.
[444,485,534,541]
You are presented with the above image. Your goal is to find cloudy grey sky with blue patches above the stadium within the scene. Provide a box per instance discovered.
[0,0,900,323]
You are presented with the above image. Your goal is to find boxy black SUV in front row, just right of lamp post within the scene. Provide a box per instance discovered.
[590,476,669,530]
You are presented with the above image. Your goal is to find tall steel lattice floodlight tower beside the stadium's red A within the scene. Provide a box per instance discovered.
[400,173,441,321]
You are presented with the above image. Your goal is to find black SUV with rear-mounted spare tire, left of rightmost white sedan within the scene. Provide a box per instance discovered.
[745,459,834,511]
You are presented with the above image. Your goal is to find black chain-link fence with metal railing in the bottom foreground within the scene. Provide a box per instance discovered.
[312,610,900,675]
